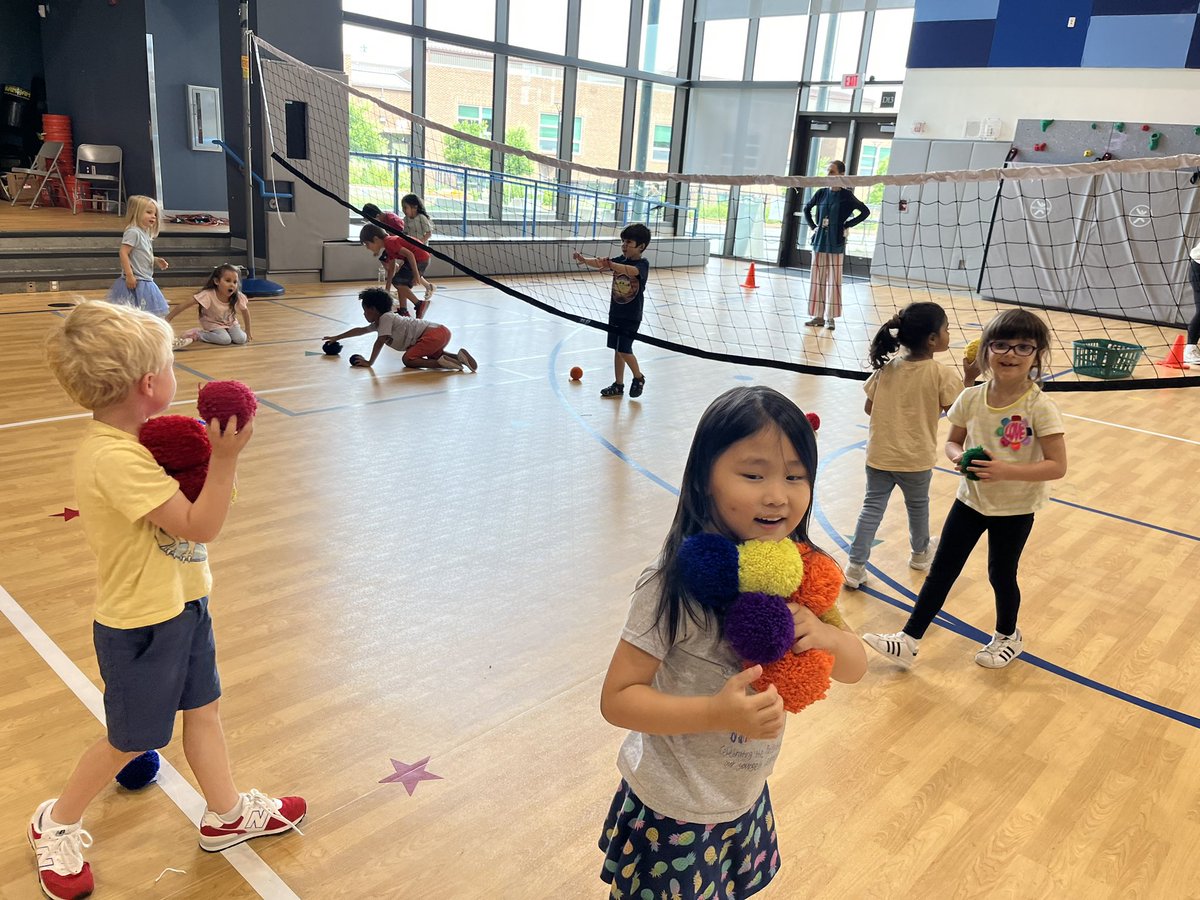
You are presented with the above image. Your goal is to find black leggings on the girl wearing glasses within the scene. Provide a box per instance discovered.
[904,500,1033,641]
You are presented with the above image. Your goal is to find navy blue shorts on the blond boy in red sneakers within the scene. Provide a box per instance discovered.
[91,596,221,752]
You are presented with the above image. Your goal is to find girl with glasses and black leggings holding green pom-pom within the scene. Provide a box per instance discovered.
[863,310,1067,668]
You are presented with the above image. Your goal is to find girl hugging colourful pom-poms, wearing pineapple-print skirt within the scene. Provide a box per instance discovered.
[600,386,866,900]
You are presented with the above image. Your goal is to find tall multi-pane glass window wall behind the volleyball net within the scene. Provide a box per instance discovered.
[338,0,914,248]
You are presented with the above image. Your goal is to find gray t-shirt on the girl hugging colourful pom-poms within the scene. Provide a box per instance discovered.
[617,566,784,824]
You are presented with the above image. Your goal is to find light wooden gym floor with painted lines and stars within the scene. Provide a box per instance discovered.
[0,281,1200,900]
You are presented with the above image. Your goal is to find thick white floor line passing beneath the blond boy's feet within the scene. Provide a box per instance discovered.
[0,587,299,900]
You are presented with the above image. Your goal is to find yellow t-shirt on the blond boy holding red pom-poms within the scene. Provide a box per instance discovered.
[74,421,212,628]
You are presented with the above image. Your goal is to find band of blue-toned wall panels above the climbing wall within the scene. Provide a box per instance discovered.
[908,0,1200,68]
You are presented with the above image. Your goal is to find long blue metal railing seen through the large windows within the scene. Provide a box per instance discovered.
[350,151,698,238]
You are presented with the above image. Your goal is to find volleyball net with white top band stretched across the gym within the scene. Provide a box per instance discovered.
[254,38,1200,390]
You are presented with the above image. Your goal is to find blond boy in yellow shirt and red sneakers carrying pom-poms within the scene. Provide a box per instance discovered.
[28,301,307,900]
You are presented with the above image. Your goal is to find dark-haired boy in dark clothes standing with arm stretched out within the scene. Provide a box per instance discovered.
[571,223,650,397]
